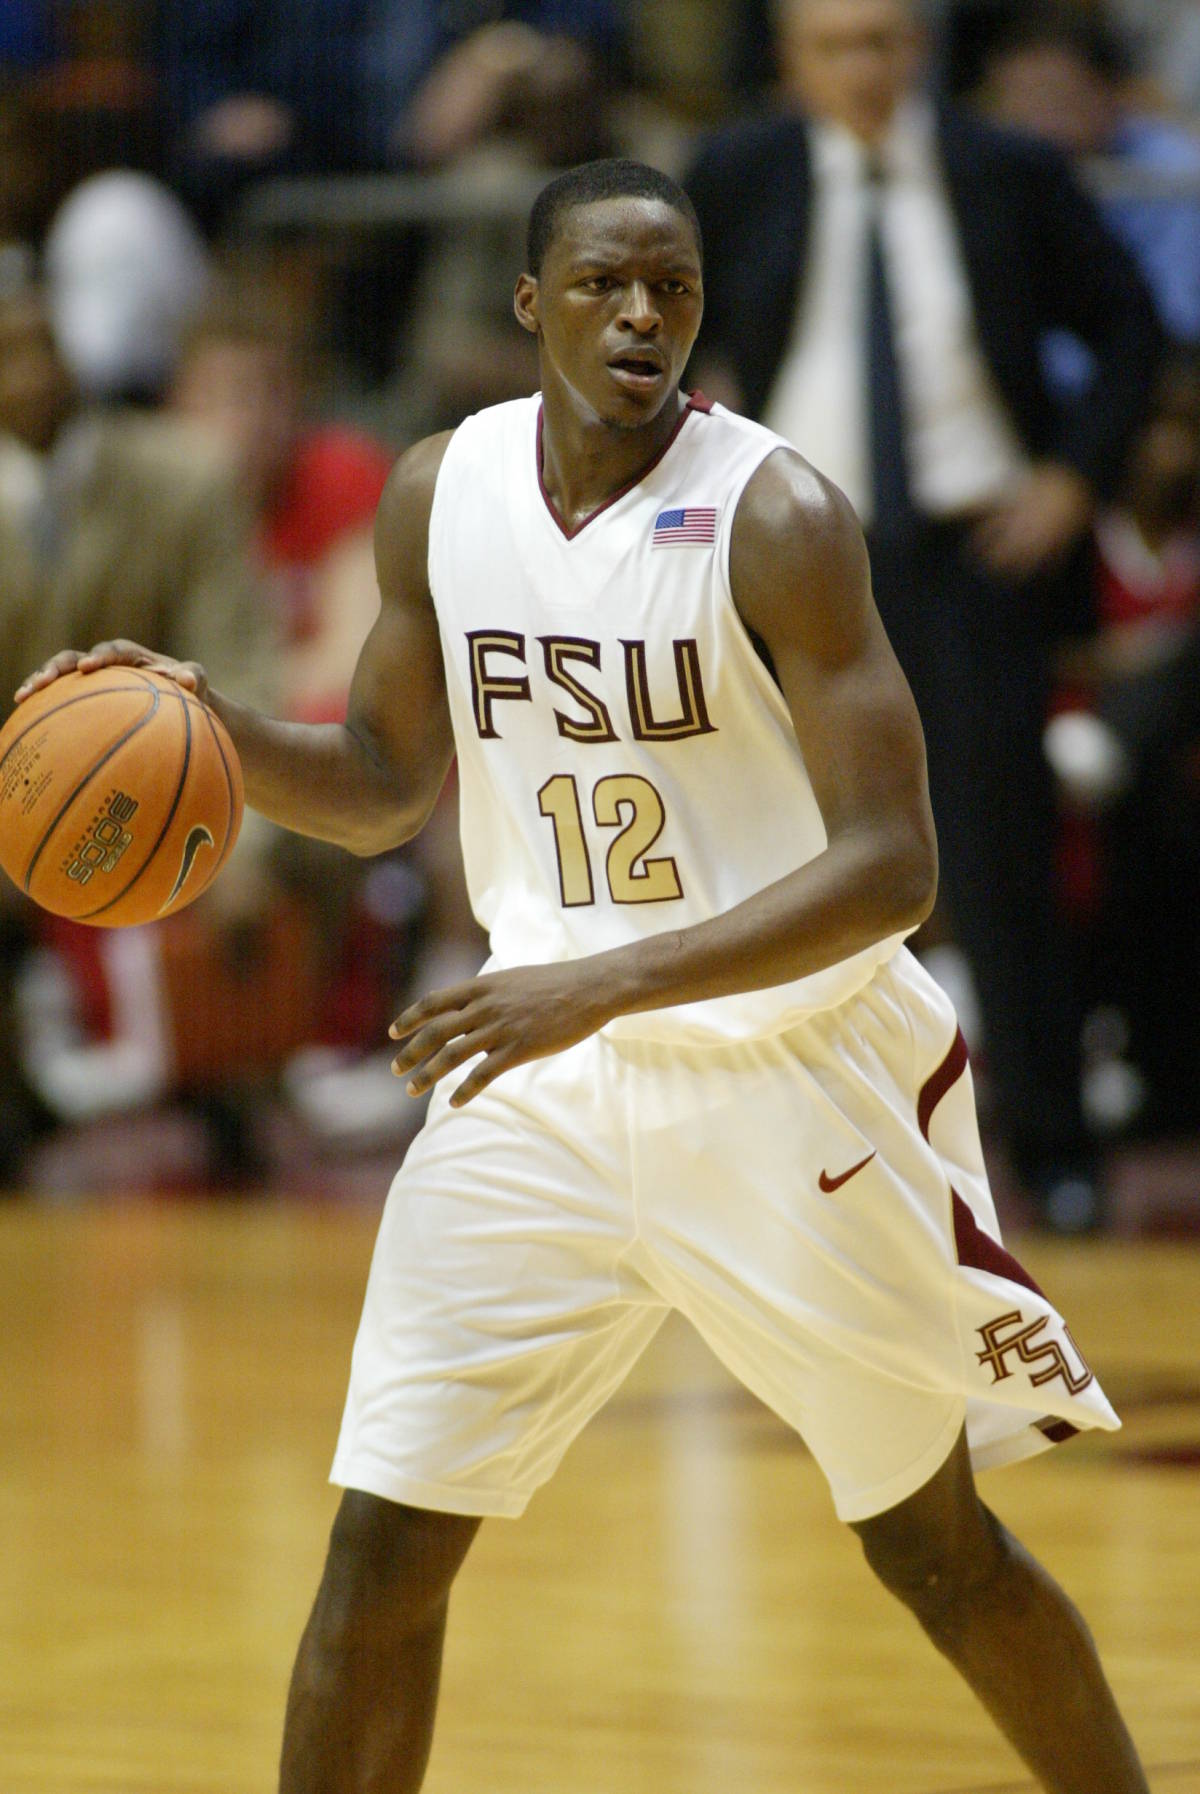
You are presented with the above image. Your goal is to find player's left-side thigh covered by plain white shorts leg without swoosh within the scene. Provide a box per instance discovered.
[334,1041,665,1514]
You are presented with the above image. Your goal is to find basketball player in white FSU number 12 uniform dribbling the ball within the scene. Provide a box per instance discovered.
[22,161,1146,1794]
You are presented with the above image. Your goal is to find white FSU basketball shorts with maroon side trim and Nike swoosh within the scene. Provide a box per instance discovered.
[332,949,1119,1520]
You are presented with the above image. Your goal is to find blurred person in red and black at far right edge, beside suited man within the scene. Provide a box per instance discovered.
[1048,357,1200,1132]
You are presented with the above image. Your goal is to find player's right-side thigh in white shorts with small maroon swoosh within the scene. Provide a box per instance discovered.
[627,981,965,1520]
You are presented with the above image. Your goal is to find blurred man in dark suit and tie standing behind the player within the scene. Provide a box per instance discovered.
[687,0,1159,1231]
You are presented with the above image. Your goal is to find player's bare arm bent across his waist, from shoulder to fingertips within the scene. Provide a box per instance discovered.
[393,450,936,1102]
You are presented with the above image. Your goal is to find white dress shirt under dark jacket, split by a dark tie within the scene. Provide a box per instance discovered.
[762,100,1028,524]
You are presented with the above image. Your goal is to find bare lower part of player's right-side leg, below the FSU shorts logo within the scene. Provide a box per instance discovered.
[852,1435,1148,1794]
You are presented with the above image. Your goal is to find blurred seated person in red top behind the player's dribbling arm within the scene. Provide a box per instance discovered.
[172,278,483,1146]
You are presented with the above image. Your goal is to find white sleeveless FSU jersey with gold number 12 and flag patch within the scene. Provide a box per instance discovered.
[429,396,902,1041]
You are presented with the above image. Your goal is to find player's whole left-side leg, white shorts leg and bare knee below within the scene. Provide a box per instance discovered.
[282,1042,665,1794]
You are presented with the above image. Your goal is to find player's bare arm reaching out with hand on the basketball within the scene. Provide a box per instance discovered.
[18,434,454,854]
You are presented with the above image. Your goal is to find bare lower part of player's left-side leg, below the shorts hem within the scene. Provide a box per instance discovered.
[280,1489,479,1794]
